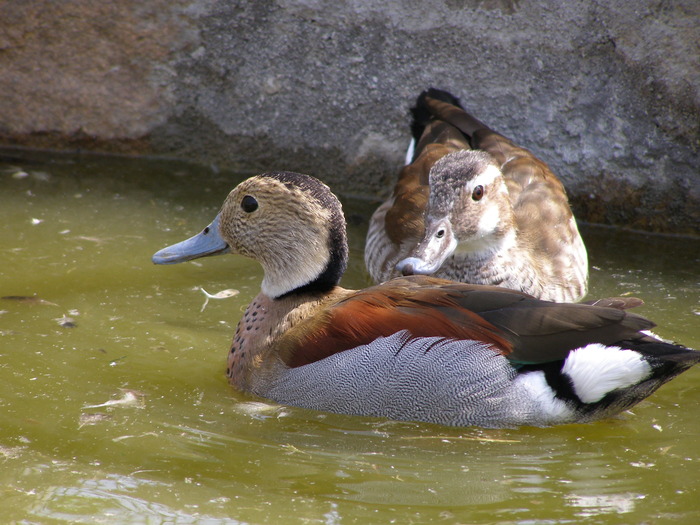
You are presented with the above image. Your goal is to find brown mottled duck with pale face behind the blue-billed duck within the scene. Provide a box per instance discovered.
[365,89,588,301]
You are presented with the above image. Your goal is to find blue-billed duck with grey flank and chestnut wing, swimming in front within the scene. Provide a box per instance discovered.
[153,172,700,427]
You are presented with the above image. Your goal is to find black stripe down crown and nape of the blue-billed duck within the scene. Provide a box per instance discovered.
[262,171,348,299]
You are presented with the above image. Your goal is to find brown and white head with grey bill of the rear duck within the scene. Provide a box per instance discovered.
[396,150,513,275]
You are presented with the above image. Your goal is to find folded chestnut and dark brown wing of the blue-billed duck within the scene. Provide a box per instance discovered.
[284,276,654,367]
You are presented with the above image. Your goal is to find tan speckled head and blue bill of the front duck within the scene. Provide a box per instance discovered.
[153,172,348,298]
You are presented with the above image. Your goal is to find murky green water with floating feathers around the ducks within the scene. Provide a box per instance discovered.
[0,149,700,524]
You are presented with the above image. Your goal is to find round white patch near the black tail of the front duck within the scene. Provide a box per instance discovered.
[562,343,651,403]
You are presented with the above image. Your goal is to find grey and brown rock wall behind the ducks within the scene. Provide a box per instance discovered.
[0,0,700,234]
